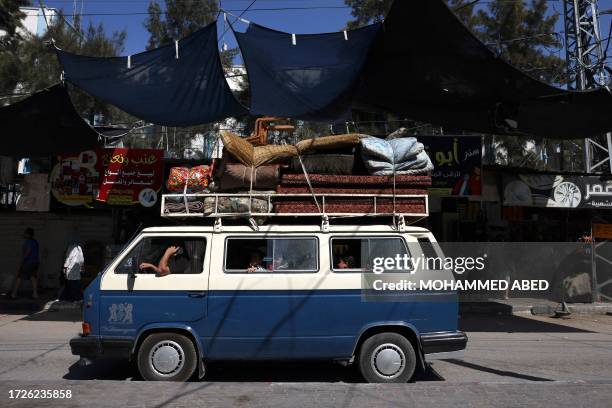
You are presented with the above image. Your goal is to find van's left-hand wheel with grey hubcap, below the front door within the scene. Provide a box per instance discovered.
[137,333,198,382]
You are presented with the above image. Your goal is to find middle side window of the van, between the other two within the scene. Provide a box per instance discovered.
[225,238,319,273]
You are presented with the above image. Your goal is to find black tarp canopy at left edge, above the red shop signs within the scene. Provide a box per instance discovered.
[0,84,98,158]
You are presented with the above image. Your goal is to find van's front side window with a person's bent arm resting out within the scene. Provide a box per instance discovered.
[115,236,206,274]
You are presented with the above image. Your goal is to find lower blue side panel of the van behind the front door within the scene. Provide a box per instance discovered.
[199,290,457,359]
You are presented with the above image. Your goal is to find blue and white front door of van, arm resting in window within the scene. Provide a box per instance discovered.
[100,233,212,337]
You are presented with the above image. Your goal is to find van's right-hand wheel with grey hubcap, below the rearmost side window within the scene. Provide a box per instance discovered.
[359,332,416,383]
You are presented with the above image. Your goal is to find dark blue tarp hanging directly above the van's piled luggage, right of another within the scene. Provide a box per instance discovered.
[235,23,381,120]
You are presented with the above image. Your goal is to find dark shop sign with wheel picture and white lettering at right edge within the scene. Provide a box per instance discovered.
[504,174,612,208]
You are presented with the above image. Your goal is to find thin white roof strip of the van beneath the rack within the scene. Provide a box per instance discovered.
[143,224,429,234]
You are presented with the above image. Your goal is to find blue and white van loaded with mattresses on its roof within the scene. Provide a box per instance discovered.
[70,225,467,382]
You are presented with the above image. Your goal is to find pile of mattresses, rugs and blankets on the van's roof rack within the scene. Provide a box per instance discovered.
[160,132,433,214]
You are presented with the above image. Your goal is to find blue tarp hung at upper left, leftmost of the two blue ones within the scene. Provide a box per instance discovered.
[57,23,246,126]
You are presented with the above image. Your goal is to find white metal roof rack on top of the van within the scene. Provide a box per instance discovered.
[161,192,429,228]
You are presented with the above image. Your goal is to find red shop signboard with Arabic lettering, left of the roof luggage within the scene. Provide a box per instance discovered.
[51,148,163,207]
